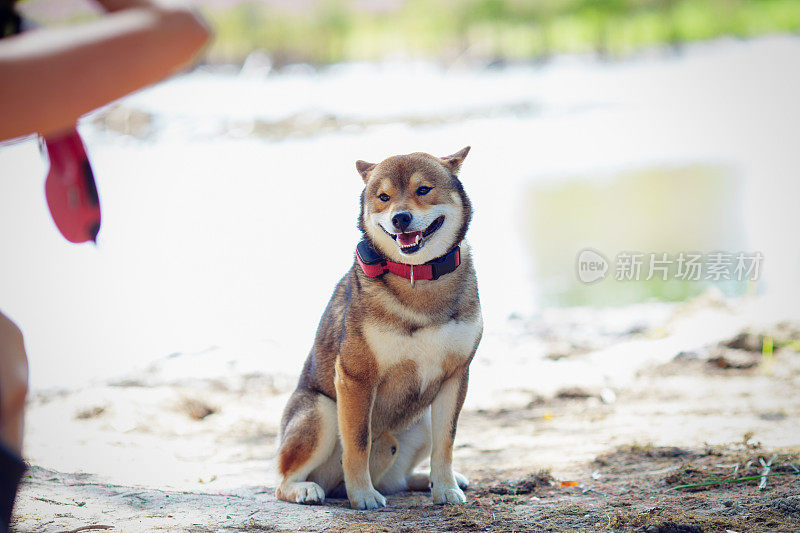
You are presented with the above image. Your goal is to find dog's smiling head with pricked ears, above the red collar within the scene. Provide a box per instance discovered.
[356,146,472,265]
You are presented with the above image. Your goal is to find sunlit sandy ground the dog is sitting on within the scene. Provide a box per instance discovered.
[13,295,800,532]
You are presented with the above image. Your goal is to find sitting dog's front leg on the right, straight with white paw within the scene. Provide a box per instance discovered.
[431,365,469,503]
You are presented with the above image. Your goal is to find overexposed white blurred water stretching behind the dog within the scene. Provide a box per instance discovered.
[0,37,800,387]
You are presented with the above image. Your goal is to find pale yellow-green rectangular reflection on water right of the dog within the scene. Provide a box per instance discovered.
[526,165,748,306]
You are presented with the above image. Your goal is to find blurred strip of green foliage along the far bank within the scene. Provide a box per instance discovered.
[198,0,800,63]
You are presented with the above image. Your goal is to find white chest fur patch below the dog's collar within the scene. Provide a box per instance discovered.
[363,314,483,390]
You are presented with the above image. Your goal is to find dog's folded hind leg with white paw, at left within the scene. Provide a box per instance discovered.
[275,389,338,503]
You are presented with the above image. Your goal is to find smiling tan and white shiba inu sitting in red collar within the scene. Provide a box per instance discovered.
[277,147,483,509]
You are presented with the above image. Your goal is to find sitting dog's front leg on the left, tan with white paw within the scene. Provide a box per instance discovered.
[335,361,386,509]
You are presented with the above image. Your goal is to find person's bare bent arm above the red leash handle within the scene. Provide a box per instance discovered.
[0,0,210,140]
